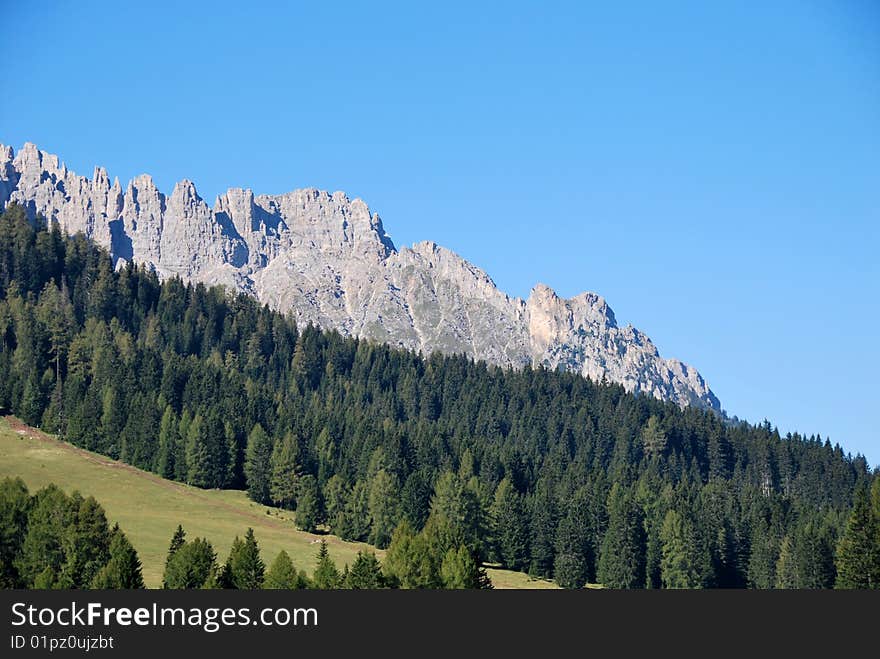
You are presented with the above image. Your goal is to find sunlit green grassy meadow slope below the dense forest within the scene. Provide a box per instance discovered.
[0,417,555,588]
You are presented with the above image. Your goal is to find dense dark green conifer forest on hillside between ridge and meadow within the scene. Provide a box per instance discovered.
[0,206,880,588]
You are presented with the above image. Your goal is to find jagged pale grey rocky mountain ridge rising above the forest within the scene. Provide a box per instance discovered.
[0,144,720,410]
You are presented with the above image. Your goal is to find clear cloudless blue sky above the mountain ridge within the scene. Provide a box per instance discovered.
[0,0,880,464]
